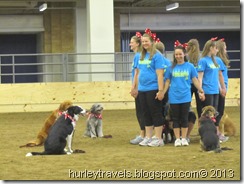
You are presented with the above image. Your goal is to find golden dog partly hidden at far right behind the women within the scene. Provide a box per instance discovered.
[219,112,236,136]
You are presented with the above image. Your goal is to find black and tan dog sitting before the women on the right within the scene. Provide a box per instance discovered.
[198,106,222,153]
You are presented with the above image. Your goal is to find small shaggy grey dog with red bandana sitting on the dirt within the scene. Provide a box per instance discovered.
[84,103,112,138]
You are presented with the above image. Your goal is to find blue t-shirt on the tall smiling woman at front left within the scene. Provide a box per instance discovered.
[138,52,166,91]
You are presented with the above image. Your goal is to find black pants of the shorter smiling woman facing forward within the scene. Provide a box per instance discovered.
[170,102,191,128]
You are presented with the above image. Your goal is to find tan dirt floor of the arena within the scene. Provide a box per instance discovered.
[0,107,241,181]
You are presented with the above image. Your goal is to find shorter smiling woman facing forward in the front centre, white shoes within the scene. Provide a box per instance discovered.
[163,44,204,147]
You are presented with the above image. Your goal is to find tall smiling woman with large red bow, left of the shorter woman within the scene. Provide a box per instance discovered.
[135,29,165,146]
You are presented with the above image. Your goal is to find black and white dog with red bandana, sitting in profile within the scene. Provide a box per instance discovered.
[26,106,85,157]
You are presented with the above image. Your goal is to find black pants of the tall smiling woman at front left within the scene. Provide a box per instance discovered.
[138,90,164,127]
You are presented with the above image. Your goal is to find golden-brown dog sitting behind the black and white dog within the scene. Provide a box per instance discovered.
[20,100,73,148]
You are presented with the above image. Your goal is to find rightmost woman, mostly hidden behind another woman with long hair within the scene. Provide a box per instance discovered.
[216,38,230,142]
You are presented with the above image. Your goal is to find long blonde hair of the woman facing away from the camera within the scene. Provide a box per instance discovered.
[186,39,200,66]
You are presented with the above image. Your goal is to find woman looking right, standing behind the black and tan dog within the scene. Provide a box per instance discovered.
[198,37,226,141]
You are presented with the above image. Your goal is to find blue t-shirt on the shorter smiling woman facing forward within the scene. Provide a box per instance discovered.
[165,62,197,104]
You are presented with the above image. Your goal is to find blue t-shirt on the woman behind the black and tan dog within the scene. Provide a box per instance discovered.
[198,56,220,94]
